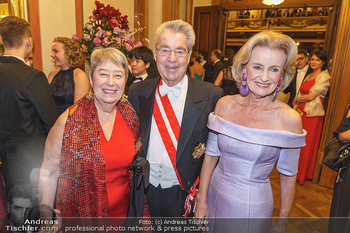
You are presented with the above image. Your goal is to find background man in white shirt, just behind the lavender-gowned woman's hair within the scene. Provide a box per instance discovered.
[283,49,312,108]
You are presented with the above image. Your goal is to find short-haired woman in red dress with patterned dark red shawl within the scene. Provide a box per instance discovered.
[39,48,141,217]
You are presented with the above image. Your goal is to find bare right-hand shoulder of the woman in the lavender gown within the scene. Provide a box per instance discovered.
[278,103,303,134]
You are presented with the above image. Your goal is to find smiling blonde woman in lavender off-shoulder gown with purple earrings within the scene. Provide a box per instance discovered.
[195,31,306,233]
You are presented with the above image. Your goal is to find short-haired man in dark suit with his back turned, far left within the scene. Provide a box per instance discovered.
[0,16,58,197]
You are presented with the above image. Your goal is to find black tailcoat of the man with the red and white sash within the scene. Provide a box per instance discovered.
[129,77,224,191]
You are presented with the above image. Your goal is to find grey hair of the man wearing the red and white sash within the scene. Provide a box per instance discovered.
[154,19,196,51]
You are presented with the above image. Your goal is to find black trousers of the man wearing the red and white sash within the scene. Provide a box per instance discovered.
[146,184,187,217]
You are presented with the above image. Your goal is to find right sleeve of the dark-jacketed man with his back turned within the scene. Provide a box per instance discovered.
[26,71,58,134]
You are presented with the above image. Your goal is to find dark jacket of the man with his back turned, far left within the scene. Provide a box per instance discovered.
[0,57,58,194]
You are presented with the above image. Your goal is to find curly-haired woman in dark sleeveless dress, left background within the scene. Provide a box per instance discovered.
[48,37,90,114]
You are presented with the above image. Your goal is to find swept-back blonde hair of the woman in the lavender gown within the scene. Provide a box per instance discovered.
[232,31,298,92]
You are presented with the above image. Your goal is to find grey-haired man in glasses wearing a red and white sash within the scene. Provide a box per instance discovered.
[129,20,224,217]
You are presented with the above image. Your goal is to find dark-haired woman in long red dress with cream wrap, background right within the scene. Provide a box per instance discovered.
[293,50,331,184]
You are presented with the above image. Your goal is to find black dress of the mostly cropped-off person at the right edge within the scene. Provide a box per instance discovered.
[328,107,350,233]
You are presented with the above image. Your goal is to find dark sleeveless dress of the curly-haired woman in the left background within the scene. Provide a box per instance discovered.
[50,68,75,115]
